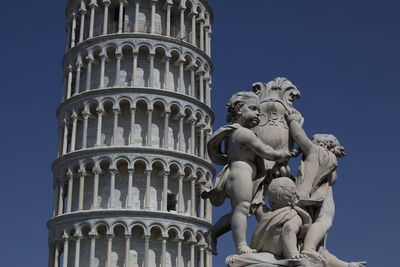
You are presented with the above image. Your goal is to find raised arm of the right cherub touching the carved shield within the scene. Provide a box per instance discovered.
[286,111,314,156]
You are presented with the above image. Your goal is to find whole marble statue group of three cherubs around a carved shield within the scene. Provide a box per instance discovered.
[202,78,366,267]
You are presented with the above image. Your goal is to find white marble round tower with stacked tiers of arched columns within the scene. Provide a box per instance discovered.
[47,0,215,267]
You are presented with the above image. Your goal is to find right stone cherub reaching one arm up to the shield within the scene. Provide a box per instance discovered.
[286,111,366,267]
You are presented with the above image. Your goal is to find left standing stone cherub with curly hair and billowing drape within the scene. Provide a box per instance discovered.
[202,92,290,254]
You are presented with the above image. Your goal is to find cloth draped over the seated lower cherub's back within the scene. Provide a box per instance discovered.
[251,205,312,252]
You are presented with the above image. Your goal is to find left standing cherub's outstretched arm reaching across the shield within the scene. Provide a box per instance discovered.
[239,129,290,161]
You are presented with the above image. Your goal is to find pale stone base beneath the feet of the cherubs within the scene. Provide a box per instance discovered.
[225,253,328,267]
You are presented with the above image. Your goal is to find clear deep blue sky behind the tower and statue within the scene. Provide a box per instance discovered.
[0,0,400,267]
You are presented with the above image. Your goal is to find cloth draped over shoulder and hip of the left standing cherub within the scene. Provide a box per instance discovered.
[205,123,265,215]
